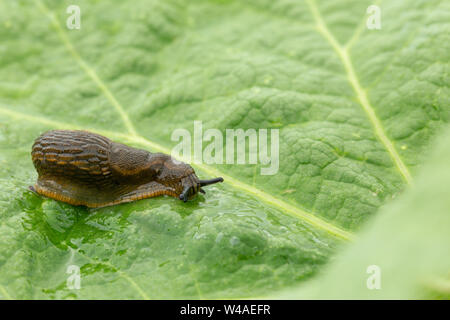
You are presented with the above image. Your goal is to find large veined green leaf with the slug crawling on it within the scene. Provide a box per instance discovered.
[0,0,450,299]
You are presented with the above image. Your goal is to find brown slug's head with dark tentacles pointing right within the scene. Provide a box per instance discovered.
[157,159,223,202]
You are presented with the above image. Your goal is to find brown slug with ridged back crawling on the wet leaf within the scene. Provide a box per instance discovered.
[30,130,223,208]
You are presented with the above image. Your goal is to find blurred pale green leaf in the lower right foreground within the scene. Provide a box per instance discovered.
[283,130,450,299]
